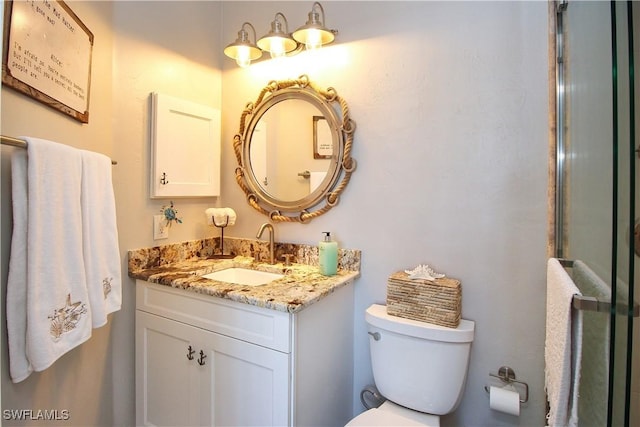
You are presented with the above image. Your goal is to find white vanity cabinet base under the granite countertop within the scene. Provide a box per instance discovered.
[136,280,353,426]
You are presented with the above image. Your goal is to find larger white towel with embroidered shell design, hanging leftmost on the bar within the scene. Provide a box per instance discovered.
[7,138,91,382]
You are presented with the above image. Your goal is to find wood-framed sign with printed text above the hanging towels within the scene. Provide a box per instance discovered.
[2,0,93,123]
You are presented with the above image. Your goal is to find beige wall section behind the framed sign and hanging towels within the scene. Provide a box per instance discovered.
[1,3,114,425]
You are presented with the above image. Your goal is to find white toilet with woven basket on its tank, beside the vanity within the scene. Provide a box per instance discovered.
[347,304,475,427]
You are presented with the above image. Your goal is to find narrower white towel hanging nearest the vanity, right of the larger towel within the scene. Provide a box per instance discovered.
[80,150,122,328]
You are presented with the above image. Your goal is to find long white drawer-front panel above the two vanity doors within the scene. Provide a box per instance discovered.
[136,280,291,353]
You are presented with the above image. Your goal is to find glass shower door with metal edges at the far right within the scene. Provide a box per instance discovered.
[556,1,640,427]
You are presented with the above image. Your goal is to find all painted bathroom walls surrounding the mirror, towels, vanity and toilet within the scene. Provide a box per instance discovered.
[2,1,548,425]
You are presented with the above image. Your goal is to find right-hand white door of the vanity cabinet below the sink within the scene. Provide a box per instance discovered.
[202,333,290,426]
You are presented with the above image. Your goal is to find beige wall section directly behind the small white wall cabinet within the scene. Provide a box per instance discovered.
[113,1,222,425]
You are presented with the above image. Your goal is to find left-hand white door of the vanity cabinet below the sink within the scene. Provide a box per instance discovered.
[136,310,200,426]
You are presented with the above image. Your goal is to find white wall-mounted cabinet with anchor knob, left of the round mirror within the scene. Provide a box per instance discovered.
[150,93,220,198]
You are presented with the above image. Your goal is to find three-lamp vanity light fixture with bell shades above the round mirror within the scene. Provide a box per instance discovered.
[224,2,338,68]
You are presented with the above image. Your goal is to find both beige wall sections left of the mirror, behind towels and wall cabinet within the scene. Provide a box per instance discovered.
[1,1,221,426]
